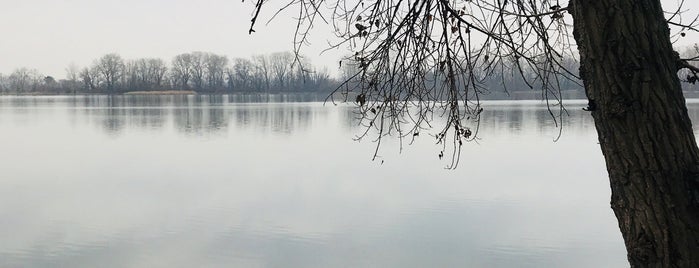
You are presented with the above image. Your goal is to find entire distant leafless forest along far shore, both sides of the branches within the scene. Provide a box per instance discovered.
[0,50,699,99]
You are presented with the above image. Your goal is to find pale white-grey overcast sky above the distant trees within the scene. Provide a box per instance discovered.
[0,0,699,78]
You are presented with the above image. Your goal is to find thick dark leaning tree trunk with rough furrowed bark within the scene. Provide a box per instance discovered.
[569,0,699,267]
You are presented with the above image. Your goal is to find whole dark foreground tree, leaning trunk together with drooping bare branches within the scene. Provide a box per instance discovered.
[249,0,699,267]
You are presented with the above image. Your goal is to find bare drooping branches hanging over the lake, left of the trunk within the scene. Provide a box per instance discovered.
[250,0,580,168]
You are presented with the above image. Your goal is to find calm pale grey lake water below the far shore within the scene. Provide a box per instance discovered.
[0,93,688,267]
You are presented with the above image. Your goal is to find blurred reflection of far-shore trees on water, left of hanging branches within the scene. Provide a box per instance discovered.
[0,95,344,135]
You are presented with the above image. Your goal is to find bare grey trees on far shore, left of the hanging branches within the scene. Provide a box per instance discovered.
[0,52,337,94]
